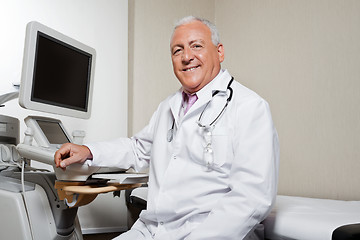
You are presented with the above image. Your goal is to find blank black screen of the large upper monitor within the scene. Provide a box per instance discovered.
[31,32,92,112]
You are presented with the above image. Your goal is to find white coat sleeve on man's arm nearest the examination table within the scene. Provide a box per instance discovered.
[186,99,279,240]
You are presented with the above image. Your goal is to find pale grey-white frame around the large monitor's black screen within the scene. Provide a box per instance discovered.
[19,21,96,119]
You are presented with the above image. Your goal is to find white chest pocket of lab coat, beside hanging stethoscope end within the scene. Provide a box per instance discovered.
[212,127,228,168]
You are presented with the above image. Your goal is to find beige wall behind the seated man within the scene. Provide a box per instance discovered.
[129,0,360,200]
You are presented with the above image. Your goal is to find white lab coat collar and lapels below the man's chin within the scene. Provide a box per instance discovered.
[169,70,231,125]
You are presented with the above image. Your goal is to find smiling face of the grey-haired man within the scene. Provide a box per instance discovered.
[170,21,224,93]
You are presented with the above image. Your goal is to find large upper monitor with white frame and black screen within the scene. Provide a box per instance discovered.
[19,22,96,119]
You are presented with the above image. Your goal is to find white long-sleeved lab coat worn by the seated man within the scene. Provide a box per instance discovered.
[87,70,279,240]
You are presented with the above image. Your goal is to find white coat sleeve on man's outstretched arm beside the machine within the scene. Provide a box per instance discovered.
[85,107,158,172]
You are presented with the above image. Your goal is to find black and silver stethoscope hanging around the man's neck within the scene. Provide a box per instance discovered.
[167,77,234,170]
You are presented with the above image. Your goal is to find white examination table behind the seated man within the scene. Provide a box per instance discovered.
[126,187,360,240]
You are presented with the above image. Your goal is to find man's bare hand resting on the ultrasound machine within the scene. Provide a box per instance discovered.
[54,143,92,170]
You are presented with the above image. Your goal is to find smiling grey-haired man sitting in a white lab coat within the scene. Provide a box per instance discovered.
[55,17,279,240]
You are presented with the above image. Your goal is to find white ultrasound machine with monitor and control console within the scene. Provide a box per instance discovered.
[0,22,143,240]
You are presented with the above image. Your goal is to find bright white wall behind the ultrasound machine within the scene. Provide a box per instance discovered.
[0,0,128,232]
